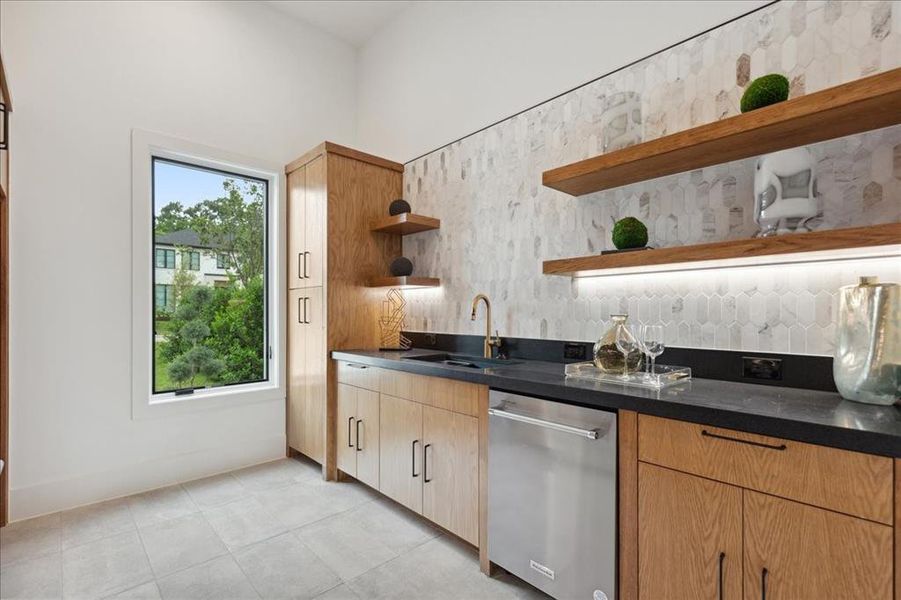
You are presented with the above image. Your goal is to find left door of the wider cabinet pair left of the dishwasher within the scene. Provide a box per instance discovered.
[379,394,422,513]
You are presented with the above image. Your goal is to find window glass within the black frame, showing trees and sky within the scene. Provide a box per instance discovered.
[152,157,269,394]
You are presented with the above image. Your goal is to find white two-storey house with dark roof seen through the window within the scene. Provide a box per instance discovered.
[153,229,233,311]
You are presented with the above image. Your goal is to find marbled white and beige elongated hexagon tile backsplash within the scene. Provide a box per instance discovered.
[404,0,901,355]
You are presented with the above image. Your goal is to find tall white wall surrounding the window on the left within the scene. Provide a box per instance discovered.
[0,1,355,519]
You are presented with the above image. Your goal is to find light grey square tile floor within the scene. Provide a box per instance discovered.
[0,459,547,600]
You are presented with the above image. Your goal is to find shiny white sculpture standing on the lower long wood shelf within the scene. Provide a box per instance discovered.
[754,148,819,237]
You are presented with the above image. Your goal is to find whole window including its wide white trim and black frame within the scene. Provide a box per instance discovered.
[132,131,285,418]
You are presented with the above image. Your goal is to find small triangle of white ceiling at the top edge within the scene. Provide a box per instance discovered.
[267,0,412,48]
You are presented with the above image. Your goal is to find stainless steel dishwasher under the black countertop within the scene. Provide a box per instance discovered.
[488,390,616,600]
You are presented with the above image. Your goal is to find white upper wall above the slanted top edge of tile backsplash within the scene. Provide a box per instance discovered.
[357,0,767,162]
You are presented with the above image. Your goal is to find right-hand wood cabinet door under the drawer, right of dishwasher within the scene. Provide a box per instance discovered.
[744,490,893,600]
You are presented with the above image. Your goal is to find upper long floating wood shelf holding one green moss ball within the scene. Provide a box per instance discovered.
[542,68,901,196]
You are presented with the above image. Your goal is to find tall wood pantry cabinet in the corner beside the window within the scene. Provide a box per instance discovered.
[285,142,403,479]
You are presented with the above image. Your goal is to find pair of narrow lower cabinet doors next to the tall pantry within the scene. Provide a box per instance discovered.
[337,383,380,488]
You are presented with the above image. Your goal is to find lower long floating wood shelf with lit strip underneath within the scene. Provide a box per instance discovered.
[544,223,901,277]
